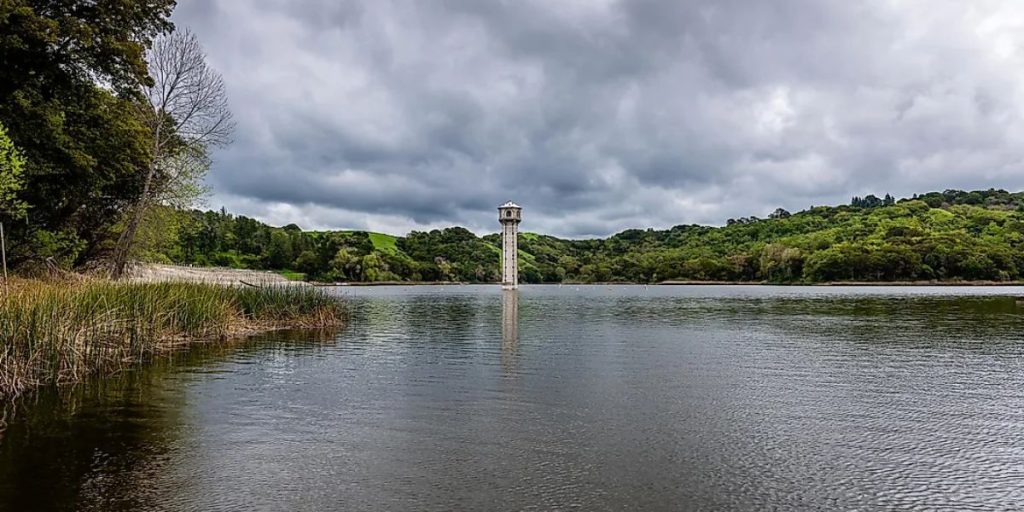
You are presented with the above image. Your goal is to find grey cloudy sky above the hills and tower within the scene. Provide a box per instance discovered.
[175,0,1024,237]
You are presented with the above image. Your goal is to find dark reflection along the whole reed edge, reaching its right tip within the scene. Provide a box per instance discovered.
[0,331,337,511]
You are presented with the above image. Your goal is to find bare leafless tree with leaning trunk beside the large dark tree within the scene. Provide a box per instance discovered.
[111,30,234,279]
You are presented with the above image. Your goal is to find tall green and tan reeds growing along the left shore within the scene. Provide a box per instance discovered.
[0,280,343,397]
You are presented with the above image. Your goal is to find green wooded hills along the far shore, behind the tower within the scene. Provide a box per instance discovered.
[143,189,1024,283]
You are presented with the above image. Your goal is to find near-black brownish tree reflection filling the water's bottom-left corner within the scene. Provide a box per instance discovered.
[0,361,184,510]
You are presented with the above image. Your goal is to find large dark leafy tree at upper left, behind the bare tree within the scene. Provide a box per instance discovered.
[0,0,175,261]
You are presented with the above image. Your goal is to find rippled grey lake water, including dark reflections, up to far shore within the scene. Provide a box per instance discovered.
[0,286,1024,511]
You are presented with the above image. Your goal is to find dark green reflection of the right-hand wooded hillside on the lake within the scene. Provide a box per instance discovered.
[535,296,1024,352]
